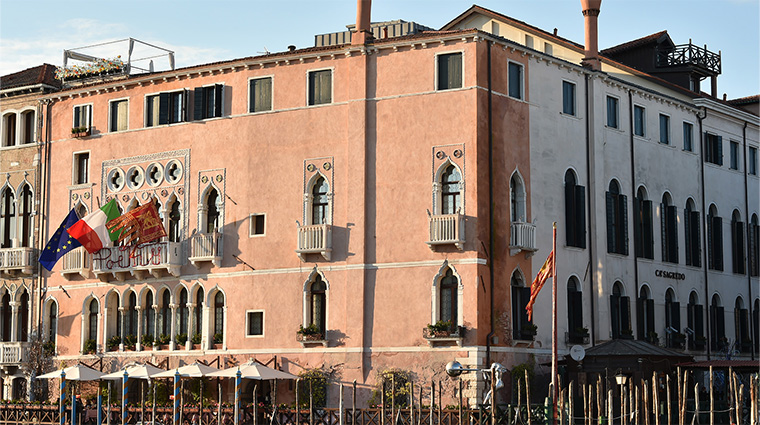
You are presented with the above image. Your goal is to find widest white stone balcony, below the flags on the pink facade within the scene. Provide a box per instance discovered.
[92,242,182,281]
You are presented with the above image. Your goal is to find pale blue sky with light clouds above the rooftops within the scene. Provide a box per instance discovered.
[0,0,760,99]
